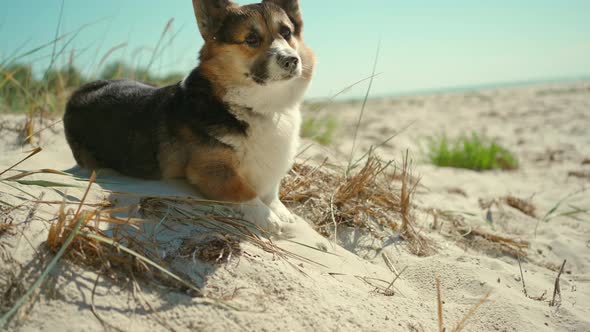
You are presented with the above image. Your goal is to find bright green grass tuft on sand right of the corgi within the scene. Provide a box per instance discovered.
[427,132,518,171]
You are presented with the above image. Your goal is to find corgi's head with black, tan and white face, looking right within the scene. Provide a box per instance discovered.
[193,0,314,95]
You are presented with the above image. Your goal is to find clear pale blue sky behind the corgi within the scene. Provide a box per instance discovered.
[0,0,590,97]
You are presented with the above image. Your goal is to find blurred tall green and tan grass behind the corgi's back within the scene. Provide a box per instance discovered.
[0,17,183,114]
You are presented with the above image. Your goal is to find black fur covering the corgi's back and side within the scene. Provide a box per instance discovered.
[64,68,248,179]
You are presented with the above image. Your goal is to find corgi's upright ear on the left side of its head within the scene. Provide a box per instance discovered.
[193,0,235,40]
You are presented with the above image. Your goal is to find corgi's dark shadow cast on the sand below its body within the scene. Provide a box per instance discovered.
[51,166,252,314]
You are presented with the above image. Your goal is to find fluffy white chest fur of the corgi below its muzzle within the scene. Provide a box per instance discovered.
[219,79,308,197]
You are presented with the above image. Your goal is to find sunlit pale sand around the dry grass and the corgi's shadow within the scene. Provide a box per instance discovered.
[0,83,590,331]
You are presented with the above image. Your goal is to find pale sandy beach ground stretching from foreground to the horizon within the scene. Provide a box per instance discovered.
[0,82,590,331]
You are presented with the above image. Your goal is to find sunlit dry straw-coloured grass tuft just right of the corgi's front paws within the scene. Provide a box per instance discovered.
[281,155,434,256]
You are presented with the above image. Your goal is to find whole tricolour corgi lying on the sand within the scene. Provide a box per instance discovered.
[63,0,315,235]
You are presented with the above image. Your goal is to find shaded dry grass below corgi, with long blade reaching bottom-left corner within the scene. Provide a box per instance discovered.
[0,176,290,327]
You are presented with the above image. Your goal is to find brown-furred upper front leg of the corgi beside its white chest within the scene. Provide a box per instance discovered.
[186,148,257,203]
